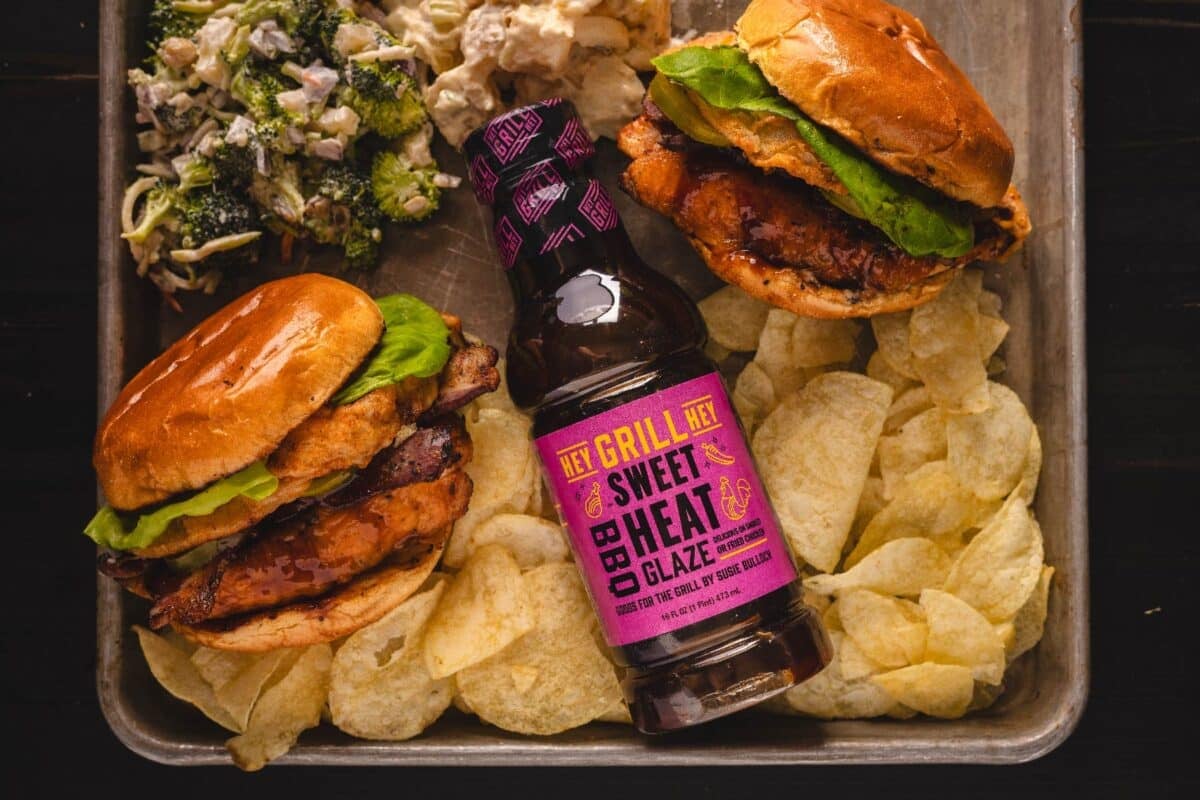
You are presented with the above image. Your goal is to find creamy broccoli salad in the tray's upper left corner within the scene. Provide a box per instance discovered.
[121,0,460,297]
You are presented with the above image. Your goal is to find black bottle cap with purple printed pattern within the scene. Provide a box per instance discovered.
[463,97,595,205]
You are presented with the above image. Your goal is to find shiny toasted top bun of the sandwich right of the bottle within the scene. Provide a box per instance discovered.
[737,0,1013,209]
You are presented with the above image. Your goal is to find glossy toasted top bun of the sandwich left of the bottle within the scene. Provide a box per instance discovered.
[92,273,383,510]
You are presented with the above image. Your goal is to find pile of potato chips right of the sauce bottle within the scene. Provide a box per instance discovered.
[701,270,1054,718]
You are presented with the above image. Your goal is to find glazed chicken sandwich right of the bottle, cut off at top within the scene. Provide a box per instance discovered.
[618,0,1030,318]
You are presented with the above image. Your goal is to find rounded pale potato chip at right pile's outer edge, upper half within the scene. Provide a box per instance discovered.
[946,383,1033,500]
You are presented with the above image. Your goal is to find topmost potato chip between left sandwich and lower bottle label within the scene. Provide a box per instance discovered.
[425,543,534,679]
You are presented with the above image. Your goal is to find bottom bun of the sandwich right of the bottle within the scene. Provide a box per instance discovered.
[688,236,959,319]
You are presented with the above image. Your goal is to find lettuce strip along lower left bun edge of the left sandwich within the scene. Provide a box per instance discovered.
[83,462,280,551]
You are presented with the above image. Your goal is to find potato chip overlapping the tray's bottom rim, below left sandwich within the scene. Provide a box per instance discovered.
[226,644,334,771]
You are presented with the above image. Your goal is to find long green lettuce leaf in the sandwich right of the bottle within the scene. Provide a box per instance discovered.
[653,47,974,258]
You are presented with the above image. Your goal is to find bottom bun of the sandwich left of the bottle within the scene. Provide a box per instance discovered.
[174,528,450,652]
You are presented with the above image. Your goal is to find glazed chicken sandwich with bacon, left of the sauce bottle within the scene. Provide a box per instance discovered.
[86,275,499,651]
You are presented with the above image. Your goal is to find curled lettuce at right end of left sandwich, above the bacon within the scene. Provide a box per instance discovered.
[331,294,450,405]
